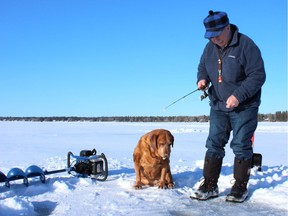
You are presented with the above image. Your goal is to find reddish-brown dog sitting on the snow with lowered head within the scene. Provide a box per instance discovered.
[133,129,174,189]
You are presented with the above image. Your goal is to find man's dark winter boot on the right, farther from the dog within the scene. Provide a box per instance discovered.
[226,158,252,203]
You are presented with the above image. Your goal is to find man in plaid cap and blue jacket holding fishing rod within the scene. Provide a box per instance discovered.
[194,11,266,202]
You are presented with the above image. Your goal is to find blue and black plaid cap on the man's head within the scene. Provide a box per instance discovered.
[203,10,229,39]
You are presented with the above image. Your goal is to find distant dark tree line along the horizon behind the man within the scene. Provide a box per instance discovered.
[0,111,287,122]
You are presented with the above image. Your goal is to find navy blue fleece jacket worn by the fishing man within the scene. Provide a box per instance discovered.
[197,24,266,111]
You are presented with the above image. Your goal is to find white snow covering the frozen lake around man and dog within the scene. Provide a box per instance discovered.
[0,122,288,216]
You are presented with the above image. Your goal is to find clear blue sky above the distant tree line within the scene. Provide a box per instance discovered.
[0,0,287,116]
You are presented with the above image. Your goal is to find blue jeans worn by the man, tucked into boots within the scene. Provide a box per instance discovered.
[206,107,258,160]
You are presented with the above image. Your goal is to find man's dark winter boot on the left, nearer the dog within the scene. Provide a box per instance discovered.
[191,157,223,200]
